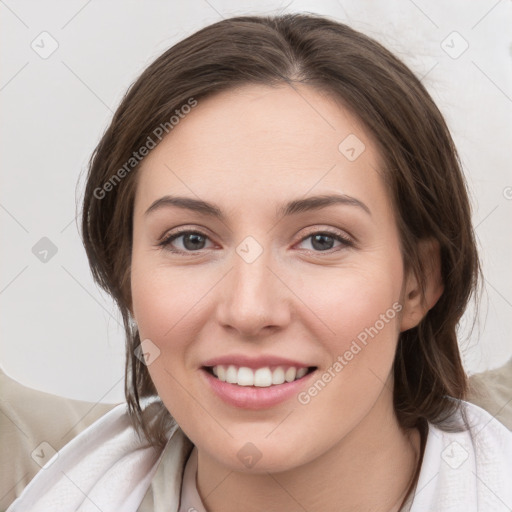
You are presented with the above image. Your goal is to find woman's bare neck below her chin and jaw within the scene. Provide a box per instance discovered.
[197,388,421,512]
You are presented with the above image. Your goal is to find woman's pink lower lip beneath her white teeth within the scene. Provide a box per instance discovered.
[201,368,316,410]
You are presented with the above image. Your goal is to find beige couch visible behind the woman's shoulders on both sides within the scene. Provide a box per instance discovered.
[0,359,512,511]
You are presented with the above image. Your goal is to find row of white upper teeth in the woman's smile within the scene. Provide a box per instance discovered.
[212,364,308,388]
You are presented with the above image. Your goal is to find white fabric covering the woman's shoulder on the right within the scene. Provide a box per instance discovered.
[411,400,512,512]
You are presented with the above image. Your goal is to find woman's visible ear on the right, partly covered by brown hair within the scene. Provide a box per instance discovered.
[400,238,444,332]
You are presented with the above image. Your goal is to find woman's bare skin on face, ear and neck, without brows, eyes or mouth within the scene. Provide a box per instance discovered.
[131,85,442,512]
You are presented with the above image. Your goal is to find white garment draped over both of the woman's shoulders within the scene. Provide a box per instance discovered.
[7,402,512,512]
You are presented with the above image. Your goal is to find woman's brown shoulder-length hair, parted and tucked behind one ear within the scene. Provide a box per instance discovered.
[82,14,480,445]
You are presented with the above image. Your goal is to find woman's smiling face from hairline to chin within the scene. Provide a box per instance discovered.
[131,85,410,472]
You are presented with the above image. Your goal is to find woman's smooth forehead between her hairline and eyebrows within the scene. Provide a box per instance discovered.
[136,85,389,218]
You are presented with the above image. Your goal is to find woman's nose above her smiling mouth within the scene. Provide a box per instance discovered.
[217,246,293,339]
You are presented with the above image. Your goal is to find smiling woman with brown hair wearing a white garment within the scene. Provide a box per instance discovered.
[8,14,512,512]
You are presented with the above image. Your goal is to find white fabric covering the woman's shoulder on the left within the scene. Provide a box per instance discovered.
[8,399,188,512]
